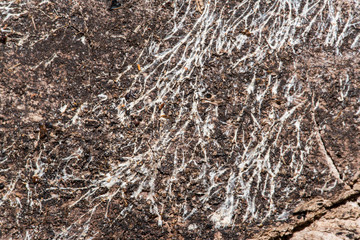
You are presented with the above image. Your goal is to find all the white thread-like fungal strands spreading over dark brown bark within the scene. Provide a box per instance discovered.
[0,0,360,239]
